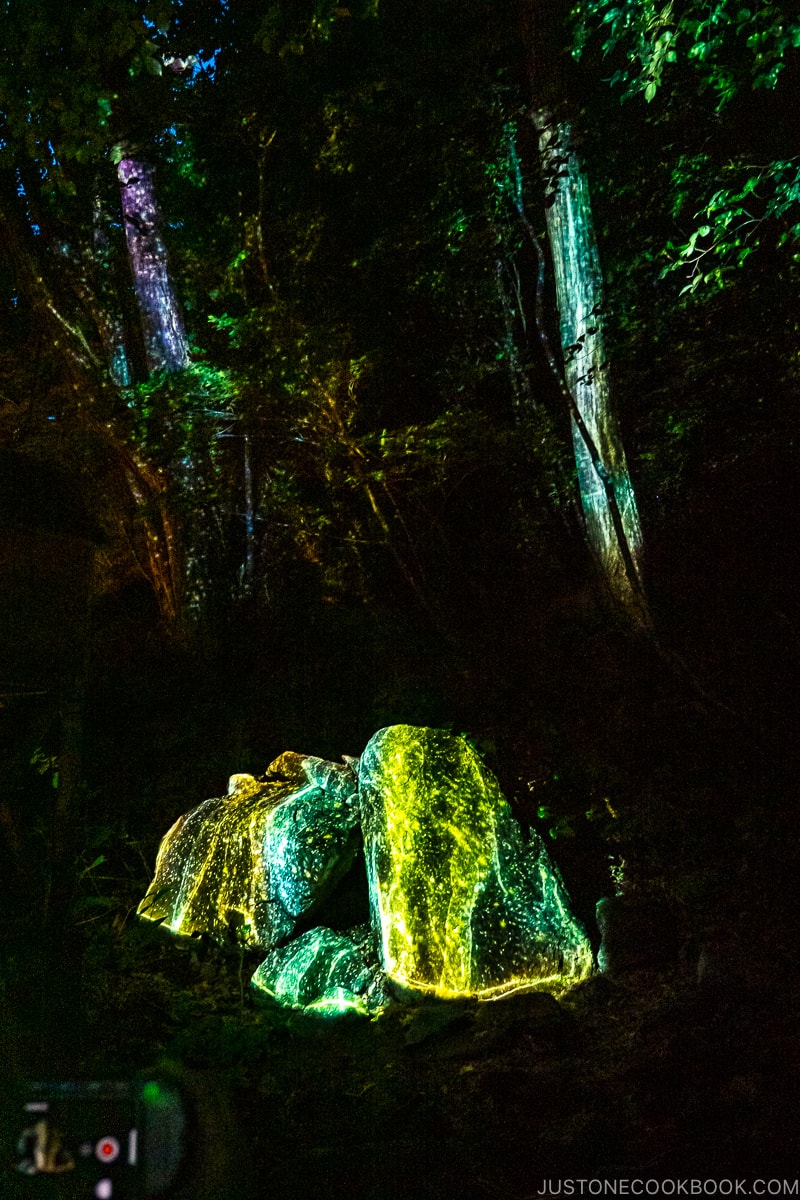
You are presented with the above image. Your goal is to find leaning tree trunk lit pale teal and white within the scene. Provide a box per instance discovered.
[534,108,649,625]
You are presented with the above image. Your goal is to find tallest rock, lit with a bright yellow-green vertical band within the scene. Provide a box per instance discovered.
[359,725,593,998]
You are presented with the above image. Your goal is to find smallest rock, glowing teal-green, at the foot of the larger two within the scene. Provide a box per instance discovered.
[251,926,389,1015]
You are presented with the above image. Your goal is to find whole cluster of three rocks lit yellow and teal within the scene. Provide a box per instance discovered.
[139,725,593,1013]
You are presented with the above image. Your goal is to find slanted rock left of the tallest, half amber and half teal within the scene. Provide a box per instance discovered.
[138,754,357,949]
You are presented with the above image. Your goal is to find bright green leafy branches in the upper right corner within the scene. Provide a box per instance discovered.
[573,0,800,295]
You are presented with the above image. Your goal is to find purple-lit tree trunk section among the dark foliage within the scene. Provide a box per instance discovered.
[118,158,188,371]
